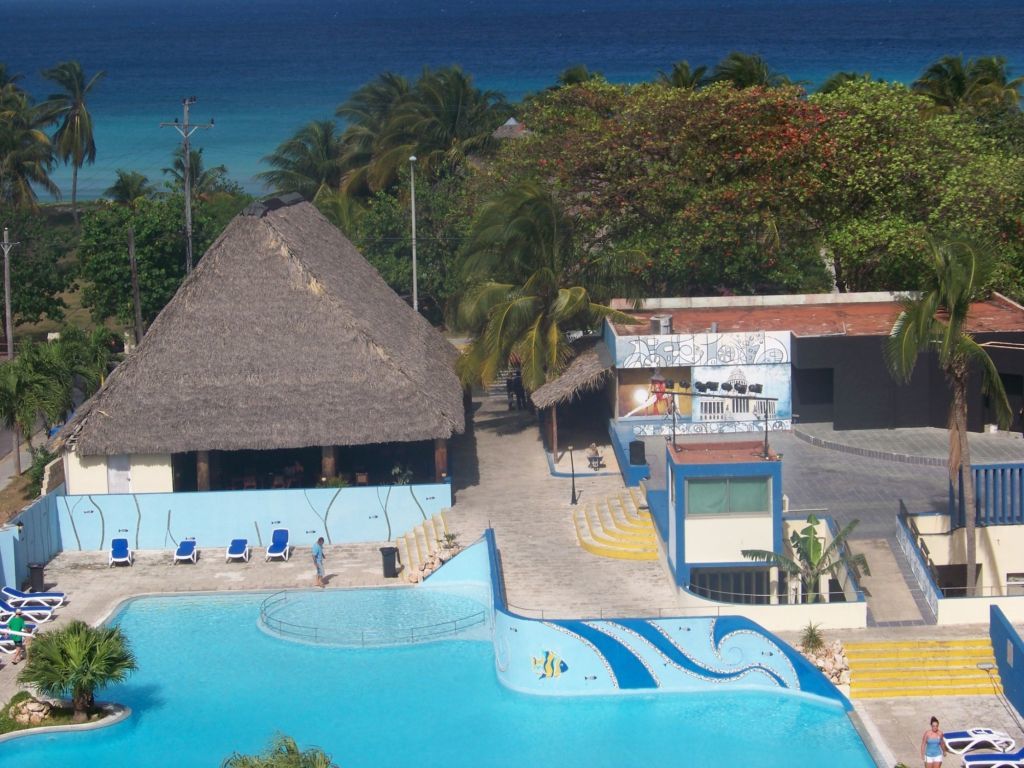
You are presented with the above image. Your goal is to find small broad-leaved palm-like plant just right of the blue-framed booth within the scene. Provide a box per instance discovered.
[740,514,871,603]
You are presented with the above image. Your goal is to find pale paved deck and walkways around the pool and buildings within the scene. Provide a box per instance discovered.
[0,391,1024,765]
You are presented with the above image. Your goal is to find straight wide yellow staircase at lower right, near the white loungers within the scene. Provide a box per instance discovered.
[845,638,1002,698]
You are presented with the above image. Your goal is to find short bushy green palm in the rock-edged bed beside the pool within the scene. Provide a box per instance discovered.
[17,620,137,723]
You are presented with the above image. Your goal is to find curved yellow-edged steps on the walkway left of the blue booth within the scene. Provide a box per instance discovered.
[572,488,658,560]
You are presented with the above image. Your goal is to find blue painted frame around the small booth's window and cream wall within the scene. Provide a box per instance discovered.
[665,447,782,587]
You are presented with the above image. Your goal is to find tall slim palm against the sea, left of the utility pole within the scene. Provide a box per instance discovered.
[43,61,106,224]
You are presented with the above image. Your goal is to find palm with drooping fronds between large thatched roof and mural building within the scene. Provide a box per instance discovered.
[458,182,635,391]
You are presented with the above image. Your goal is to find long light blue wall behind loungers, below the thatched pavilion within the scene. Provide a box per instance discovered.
[55,483,452,551]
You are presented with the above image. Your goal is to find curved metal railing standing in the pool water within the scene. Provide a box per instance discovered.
[259,592,487,648]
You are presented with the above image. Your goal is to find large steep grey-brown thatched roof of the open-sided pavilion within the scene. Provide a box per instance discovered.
[61,198,464,456]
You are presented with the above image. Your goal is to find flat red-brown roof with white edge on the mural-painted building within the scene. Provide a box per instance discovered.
[613,293,1024,336]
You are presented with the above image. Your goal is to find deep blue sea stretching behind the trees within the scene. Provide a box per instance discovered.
[0,0,1024,198]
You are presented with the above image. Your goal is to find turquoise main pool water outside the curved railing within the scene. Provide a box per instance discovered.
[0,593,873,768]
